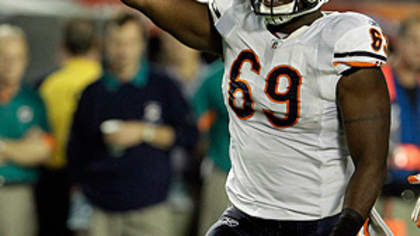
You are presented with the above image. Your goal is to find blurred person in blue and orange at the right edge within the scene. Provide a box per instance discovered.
[382,17,420,236]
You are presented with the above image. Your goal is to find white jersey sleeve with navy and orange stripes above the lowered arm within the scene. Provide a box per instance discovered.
[332,20,387,74]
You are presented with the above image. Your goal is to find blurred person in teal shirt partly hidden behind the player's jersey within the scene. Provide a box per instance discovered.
[192,60,231,235]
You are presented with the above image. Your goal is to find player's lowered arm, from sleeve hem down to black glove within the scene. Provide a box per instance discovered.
[332,68,390,236]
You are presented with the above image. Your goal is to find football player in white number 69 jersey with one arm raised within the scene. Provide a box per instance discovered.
[122,0,392,236]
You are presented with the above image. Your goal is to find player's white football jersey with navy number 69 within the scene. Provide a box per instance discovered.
[209,0,386,220]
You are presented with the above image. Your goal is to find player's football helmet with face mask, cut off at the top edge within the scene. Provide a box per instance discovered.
[251,0,328,25]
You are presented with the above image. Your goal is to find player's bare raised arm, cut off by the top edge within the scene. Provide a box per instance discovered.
[121,0,221,54]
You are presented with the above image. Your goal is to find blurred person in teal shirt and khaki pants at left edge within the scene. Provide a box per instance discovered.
[0,25,53,236]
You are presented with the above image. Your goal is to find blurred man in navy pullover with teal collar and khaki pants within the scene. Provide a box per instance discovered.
[68,15,198,236]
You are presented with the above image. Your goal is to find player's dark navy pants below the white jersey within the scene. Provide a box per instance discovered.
[207,207,338,236]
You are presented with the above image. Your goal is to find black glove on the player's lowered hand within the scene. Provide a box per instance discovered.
[329,208,365,236]
